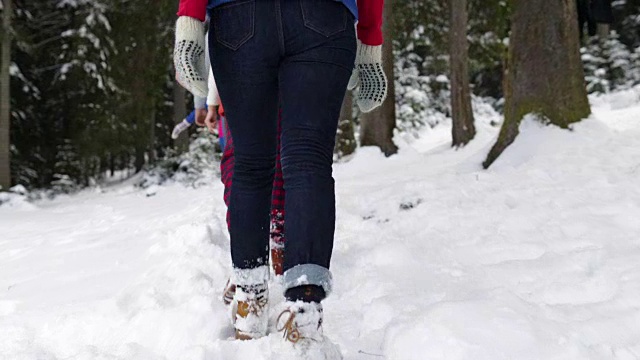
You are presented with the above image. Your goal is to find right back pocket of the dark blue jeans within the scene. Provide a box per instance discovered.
[300,0,348,37]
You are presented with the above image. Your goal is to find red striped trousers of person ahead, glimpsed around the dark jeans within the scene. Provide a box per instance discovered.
[219,116,285,248]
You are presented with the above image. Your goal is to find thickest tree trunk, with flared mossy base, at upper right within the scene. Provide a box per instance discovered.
[483,0,591,168]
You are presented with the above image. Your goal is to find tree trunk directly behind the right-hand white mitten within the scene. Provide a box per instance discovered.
[360,0,398,156]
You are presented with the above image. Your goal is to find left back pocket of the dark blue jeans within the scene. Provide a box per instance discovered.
[212,0,256,50]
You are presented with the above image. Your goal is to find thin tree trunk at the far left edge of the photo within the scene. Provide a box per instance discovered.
[0,0,13,190]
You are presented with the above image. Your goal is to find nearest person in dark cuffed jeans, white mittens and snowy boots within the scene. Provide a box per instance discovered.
[175,0,387,348]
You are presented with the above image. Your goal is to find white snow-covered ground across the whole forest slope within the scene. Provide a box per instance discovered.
[0,91,640,360]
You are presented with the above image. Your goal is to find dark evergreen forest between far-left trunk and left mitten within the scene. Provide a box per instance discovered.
[5,0,180,191]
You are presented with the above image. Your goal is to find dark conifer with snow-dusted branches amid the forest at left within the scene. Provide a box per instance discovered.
[54,0,116,185]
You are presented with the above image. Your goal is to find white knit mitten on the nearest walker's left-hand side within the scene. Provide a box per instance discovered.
[173,16,208,98]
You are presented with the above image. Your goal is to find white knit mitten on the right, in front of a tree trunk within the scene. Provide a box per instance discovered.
[348,40,387,112]
